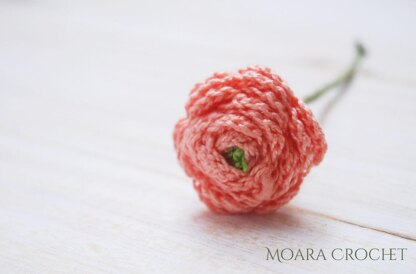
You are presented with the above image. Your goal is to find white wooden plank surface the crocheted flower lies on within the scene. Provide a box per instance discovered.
[0,0,416,273]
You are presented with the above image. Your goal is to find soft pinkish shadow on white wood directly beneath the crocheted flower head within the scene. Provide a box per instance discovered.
[185,205,334,258]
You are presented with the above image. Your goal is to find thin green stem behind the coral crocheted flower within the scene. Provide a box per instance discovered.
[303,43,366,104]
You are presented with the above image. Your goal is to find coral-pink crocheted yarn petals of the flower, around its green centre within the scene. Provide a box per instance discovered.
[173,66,327,213]
